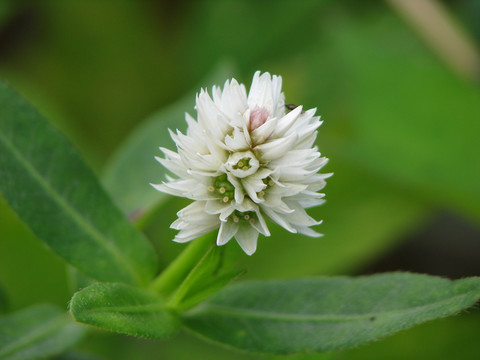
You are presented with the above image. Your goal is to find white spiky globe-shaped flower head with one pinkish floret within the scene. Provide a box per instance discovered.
[153,71,331,255]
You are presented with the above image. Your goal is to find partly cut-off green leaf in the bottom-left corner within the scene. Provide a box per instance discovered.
[0,305,86,360]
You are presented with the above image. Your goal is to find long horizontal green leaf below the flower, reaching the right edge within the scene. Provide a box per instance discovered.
[183,273,480,354]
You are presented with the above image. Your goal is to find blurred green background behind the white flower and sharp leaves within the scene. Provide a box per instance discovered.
[0,0,480,359]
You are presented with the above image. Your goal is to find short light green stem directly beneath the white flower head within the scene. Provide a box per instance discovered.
[151,234,212,296]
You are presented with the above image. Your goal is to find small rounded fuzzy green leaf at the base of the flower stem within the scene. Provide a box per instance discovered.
[70,283,180,339]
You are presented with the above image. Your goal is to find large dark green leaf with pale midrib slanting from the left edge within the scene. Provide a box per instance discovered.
[0,83,156,284]
